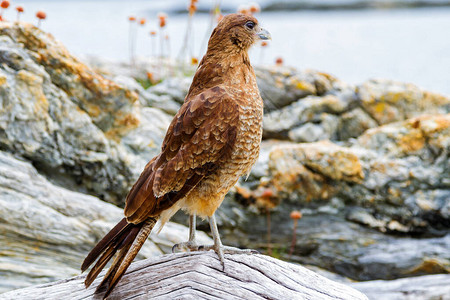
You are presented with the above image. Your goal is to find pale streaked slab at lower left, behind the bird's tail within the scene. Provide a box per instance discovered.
[0,151,212,292]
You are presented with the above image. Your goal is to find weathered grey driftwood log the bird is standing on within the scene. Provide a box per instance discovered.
[0,251,367,300]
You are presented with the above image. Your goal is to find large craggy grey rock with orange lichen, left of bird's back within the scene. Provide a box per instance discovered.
[0,22,170,203]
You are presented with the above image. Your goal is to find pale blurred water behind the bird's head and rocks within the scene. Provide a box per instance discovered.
[5,0,450,95]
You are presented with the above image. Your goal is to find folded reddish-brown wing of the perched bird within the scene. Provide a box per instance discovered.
[125,86,239,223]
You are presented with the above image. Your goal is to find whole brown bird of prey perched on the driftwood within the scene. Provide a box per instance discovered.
[81,14,270,297]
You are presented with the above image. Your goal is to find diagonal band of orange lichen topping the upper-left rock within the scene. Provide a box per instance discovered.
[0,23,138,139]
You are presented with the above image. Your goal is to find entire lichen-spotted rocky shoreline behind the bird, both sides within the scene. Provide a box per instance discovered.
[0,22,450,299]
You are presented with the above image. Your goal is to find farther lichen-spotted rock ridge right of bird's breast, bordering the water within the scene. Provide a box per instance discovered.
[261,73,450,142]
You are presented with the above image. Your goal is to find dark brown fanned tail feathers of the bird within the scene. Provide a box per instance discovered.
[81,217,158,298]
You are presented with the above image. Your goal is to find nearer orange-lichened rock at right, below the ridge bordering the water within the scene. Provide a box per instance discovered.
[246,114,450,235]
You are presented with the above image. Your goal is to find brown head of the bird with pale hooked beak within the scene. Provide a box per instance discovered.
[208,14,271,53]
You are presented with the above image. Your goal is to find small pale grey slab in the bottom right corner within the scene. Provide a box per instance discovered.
[350,274,450,300]
